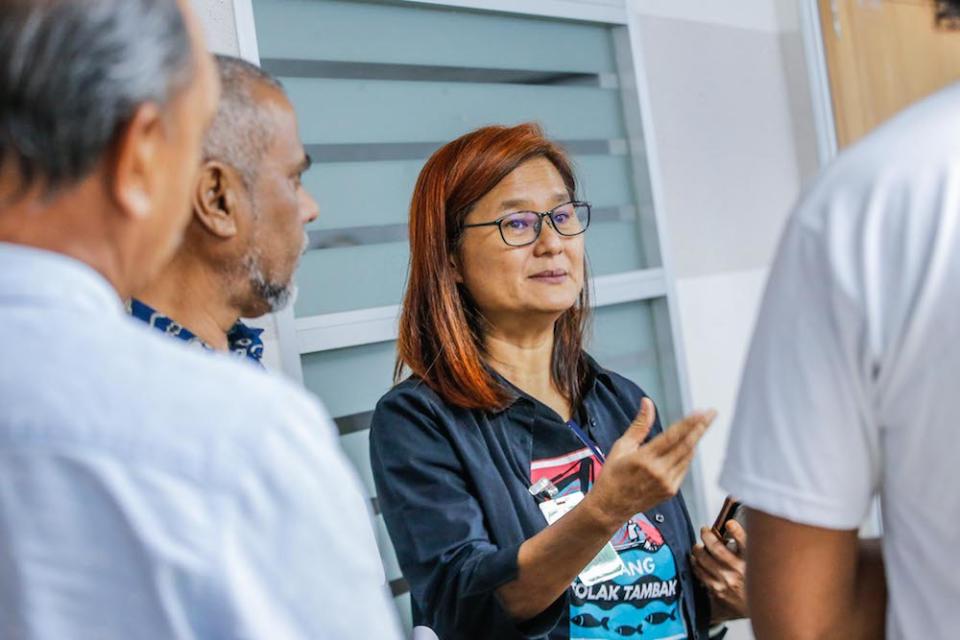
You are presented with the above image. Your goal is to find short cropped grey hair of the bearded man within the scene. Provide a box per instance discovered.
[203,55,283,188]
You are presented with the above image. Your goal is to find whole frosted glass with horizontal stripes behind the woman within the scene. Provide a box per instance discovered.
[253,0,679,629]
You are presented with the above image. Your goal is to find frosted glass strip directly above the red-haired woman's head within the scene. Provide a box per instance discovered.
[284,78,625,144]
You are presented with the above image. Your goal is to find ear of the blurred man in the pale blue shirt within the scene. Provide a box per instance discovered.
[108,103,166,219]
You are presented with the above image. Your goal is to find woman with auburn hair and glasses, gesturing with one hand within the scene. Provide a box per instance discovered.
[370,124,746,640]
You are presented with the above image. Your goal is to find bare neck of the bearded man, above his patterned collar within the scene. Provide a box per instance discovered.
[134,252,240,351]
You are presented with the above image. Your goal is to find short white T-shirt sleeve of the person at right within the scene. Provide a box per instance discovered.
[720,195,879,529]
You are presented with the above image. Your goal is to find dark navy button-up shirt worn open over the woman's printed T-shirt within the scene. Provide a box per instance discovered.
[370,360,710,640]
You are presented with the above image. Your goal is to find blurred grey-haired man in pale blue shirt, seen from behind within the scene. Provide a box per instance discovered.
[0,0,399,640]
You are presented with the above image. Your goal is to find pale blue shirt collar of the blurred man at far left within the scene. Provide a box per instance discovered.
[0,242,123,315]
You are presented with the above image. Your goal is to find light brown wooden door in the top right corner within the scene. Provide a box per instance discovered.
[818,0,960,148]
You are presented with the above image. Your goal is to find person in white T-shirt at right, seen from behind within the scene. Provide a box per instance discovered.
[721,79,960,640]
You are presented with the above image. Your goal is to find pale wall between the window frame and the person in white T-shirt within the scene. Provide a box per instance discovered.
[630,0,817,640]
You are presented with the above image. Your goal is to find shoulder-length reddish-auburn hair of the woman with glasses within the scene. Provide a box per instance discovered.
[394,123,590,410]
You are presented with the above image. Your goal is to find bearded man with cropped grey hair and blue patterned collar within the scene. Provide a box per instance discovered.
[129,56,318,364]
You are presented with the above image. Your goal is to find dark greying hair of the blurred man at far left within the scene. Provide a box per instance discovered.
[0,0,193,196]
